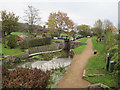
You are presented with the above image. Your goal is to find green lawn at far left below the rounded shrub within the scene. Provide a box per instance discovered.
[0,44,23,56]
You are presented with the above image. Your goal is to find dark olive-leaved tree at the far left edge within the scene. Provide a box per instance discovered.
[1,10,19,36]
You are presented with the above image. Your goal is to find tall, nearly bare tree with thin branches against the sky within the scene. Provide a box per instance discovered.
[24,6,41,33]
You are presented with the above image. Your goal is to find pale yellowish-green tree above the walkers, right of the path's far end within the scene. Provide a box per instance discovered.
[94,19,103,37]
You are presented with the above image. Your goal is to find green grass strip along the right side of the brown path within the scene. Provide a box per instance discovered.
[85,38,117,87]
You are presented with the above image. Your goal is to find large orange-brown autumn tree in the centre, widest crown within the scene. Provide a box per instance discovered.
[47,11,74,36]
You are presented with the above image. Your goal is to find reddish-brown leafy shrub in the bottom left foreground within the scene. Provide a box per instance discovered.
[2,68,50,88]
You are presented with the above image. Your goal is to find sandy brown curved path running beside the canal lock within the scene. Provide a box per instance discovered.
[56,39,94,88]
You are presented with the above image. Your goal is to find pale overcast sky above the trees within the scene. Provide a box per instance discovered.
[0,0,119,27]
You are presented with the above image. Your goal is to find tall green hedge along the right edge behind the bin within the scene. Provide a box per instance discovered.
[105,32,120,86]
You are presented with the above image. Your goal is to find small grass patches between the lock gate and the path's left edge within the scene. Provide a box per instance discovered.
[74,38,88,54]
